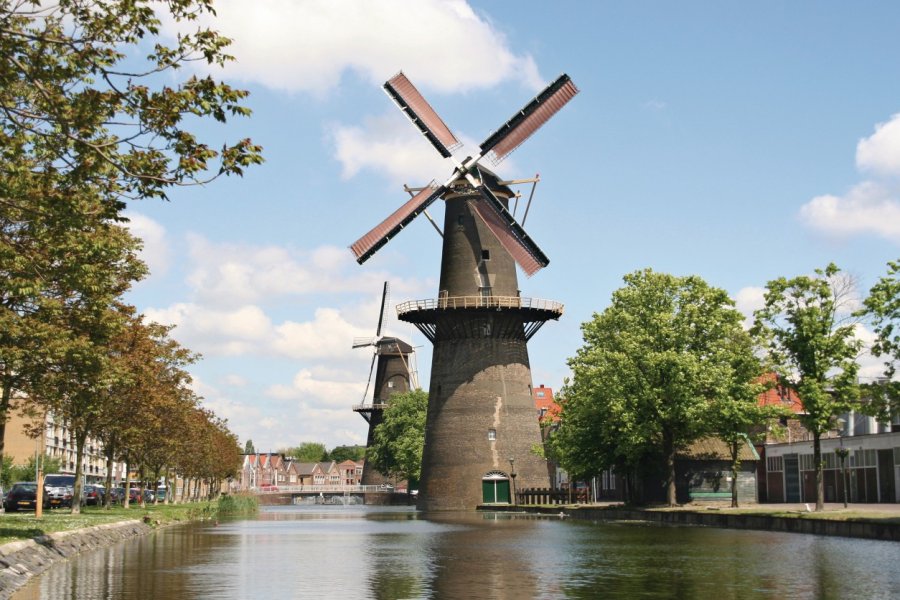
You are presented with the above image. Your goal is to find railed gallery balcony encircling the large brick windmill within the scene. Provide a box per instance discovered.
[397,296,563,343]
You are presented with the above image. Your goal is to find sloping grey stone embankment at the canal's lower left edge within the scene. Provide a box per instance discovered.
[0,520,153,600]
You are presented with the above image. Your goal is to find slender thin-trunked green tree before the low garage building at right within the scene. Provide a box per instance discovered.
[752,263,862,511]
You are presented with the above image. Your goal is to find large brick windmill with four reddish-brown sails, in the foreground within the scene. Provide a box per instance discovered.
[351,73,578,510]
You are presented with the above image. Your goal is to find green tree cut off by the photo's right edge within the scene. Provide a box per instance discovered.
[859,260,900,422]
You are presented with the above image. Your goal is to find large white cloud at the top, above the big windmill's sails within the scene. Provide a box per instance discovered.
[166,0,541,94]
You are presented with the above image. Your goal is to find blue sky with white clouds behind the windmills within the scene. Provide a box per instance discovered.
[128,0,900,451]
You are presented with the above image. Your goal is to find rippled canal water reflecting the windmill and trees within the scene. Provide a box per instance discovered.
[13,506,900,600]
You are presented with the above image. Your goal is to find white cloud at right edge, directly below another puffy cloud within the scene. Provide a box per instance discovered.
[800,181,900,242]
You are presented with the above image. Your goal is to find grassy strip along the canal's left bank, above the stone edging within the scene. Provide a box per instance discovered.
[0,496,258,544]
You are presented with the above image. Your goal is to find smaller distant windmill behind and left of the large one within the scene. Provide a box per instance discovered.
[353,281,414,485]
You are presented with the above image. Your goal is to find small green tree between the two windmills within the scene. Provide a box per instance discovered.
[366,390,428,491]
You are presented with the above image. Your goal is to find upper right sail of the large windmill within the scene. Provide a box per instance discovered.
[481,73,578,164]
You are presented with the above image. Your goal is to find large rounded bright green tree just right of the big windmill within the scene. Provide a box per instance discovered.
[552,269,753,505]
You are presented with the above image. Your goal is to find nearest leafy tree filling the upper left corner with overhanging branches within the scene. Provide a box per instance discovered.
[0,0,261,482]
